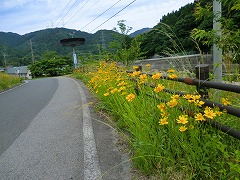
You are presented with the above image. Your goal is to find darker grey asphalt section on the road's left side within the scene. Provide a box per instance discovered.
[0,78,58,155]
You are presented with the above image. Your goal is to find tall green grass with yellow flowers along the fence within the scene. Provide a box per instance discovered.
[75,62,240,179]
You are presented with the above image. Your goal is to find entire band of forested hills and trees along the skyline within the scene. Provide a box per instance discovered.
[0,0,240,66]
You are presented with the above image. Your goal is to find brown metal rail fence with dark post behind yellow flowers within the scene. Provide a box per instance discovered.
[126,64,240,140]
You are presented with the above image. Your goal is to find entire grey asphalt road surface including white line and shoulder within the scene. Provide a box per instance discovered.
[0,77,131,180]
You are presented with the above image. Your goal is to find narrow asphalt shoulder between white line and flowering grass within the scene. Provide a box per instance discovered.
[75,79,132,180]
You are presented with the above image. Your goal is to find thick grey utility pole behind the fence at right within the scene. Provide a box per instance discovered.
[213,0,222,82]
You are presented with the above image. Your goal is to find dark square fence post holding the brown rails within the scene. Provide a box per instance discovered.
[195,64,209,99]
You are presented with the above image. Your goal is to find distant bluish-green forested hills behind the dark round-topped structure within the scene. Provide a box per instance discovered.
[0,28,120,66]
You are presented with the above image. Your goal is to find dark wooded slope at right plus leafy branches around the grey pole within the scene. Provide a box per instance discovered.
[139,0,240,62]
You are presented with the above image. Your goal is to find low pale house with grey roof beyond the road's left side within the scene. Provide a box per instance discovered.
[6,66,32,79]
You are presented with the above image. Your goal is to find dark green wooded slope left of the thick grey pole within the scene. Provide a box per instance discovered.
[141,3,206,57]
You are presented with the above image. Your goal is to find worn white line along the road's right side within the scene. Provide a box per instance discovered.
[73,80,101,180]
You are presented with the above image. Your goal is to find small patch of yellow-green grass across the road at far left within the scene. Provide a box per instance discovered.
[0,73,21,91]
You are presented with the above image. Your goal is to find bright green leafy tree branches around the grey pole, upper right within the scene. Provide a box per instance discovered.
[192,0,240,63]
